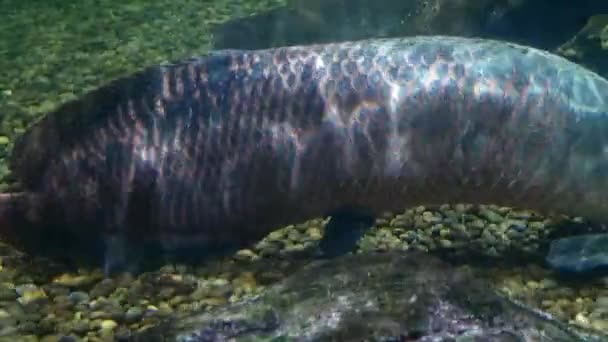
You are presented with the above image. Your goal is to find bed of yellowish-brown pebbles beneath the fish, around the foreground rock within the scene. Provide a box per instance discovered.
[0,204,608,341]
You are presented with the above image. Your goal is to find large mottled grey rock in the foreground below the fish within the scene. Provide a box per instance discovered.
[135,253,600,342]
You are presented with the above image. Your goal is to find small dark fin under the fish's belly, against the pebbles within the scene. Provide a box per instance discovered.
[317,208,375,258]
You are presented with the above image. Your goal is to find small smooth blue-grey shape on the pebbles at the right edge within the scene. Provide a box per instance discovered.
[547,233,608,274]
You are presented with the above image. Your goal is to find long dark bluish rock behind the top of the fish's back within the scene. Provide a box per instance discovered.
[214,0,608,49]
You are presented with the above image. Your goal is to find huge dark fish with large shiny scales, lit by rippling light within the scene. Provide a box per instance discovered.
[3,36,608,268]
